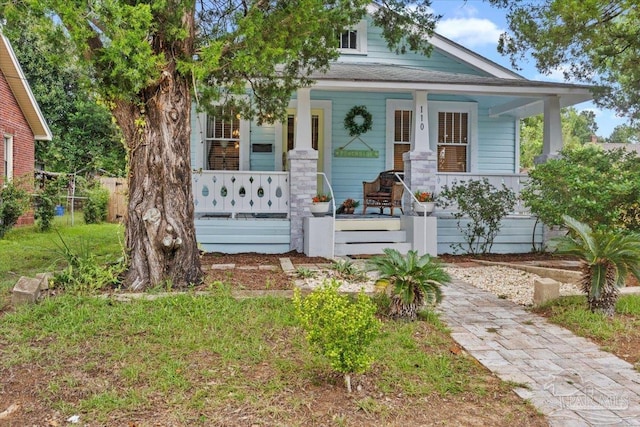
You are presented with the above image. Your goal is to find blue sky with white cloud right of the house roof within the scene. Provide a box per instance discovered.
[431,0,626,137]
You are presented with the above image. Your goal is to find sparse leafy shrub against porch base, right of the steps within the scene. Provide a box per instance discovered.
[438,178,516,254]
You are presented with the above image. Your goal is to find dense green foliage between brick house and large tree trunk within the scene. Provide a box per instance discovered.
[3,19,126,176]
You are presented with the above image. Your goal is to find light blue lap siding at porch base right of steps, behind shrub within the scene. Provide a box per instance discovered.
[438,217,542,254]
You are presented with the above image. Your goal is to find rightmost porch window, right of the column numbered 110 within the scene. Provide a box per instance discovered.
[437,111,469,172]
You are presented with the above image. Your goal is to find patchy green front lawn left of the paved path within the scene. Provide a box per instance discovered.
[0,216,546,426]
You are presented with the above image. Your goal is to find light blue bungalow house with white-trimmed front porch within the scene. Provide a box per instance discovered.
[191,10,592,257]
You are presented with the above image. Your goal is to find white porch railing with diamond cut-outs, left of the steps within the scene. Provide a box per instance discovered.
[191,171,289,217]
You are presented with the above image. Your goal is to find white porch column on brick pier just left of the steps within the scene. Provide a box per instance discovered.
[287,88,318,252]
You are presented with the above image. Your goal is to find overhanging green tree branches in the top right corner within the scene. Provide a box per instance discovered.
[487,0,640,120]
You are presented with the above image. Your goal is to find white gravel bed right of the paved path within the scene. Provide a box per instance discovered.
[446,266,581,306]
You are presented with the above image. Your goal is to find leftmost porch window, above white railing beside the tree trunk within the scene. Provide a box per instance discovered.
[204,107,240,170]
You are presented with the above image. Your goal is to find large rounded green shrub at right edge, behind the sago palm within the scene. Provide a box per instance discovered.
[521,145,640,231]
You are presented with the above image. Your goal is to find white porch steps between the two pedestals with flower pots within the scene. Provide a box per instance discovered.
[334,218,411,256]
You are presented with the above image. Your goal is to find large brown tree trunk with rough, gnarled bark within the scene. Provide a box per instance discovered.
[113,67,202,290]
